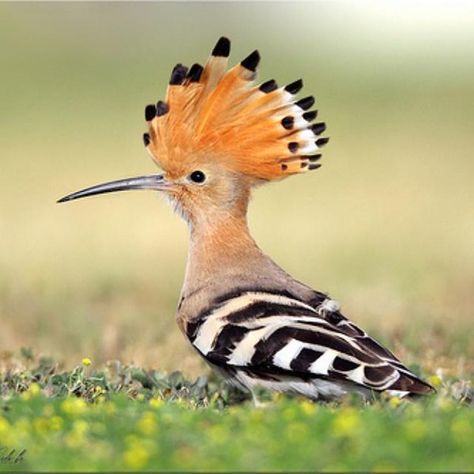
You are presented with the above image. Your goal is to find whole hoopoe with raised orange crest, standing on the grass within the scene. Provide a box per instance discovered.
[59,37,433,399]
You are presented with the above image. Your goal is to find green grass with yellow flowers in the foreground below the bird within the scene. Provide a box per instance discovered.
[0,350,474,472]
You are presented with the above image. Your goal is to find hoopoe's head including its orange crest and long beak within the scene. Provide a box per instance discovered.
[59,38,328,225]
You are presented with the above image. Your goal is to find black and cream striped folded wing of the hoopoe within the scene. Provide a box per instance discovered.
[188,291,430,393]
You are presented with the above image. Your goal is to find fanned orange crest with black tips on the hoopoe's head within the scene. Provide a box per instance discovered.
[144,38,329,180]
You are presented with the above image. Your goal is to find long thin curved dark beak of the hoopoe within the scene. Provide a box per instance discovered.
[57,174,171,202]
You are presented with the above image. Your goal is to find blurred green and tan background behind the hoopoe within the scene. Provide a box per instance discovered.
[0,2,474,375]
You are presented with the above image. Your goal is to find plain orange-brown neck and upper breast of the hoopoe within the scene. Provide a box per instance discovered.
[177,193,314,330]
